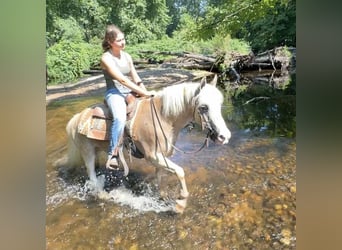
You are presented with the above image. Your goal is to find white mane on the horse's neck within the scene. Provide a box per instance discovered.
[159,83,199,116]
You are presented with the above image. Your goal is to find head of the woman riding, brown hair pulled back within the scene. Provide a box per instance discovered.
[102,24,125,51]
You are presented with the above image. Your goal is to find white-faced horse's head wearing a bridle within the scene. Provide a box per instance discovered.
[193,75,231,144]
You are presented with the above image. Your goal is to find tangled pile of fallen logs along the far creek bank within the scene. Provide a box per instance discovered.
[83,47,296,79]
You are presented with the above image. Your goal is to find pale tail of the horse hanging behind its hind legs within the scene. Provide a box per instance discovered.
[66,113,82,167]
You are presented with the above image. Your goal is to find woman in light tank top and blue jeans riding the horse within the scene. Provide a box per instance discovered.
[100,25,152,168]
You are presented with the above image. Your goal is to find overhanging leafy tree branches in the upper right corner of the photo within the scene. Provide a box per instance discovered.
[184,0,296,50]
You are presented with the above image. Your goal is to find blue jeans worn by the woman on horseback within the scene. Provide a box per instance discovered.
[105,89,128,156]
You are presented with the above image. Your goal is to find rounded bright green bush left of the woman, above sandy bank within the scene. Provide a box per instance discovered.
[46,40,101,83]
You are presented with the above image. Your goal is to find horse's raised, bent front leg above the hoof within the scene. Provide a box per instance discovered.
[154,154,189,198]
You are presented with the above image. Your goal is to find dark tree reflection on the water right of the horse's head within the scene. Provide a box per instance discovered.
[222,74,296,138]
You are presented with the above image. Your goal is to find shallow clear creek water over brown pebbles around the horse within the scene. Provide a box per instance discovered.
[46,73,296,250]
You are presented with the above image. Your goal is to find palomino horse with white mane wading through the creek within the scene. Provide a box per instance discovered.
[66,76,231,212]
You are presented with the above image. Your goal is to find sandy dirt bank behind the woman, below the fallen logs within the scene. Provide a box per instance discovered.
[46,67,210,105]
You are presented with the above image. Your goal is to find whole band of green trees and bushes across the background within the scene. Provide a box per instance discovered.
[46,0,296,82]
